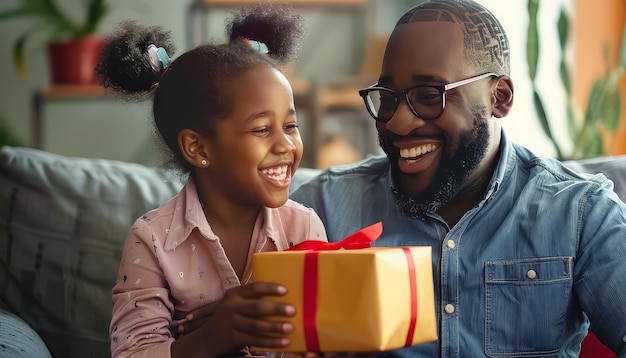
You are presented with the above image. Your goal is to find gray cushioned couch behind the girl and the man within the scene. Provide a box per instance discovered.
[0,147,626,358]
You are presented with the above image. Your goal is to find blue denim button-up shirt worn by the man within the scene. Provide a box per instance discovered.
[292,133,626,358]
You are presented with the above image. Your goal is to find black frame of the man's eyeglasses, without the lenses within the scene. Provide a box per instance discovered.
[359,72,498,123]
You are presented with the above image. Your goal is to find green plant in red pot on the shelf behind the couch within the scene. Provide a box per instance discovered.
[0,0,110,84]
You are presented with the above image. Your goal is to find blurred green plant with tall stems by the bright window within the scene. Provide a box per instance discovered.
[526,0,626,160]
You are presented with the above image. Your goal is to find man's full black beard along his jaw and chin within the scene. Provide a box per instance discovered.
[381,109,490,218]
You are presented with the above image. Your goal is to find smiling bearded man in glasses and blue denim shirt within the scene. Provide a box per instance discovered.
[292,0,626,358]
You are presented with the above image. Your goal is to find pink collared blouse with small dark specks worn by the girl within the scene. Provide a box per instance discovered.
[110,179,327,358]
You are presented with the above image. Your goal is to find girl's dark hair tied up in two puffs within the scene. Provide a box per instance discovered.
[96,4,304,171]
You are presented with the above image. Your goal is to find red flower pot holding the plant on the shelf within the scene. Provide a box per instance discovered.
[48,35,104,85]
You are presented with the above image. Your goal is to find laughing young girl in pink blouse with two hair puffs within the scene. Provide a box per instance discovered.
[96,5,326,358]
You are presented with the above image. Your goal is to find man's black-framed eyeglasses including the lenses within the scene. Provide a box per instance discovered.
[359,72,498,122]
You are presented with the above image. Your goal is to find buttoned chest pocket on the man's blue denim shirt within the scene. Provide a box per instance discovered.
[485,257,572,357]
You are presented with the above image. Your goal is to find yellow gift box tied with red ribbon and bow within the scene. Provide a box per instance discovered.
[252,223,437,352]
